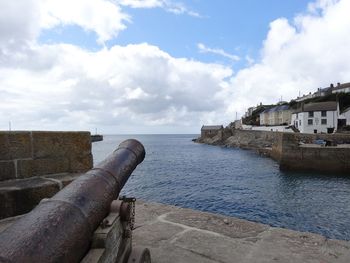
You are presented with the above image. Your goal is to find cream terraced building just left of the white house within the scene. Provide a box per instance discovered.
[260,105,292,126]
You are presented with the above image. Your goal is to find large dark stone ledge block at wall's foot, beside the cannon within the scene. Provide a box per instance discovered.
[0,178,59,219]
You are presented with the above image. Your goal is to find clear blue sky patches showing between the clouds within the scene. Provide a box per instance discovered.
[40,0,309,69]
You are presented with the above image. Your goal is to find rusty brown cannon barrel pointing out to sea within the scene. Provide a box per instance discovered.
[0,140,145,263]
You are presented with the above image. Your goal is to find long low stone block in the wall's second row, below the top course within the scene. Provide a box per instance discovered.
[17,157,70,178]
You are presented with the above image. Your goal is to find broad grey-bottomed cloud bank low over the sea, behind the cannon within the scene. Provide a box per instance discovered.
[0,44,232,132]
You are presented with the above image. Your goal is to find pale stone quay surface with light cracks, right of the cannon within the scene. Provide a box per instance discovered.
[133,201,350,263]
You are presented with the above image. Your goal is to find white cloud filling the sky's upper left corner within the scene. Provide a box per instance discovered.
[0,0,130,47]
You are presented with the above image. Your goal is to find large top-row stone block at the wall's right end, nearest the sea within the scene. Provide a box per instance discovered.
[32,132,91,159]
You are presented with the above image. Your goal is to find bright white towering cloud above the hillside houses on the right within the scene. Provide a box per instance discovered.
[227,0,350,116]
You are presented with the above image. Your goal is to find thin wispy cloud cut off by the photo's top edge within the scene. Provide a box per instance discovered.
[117,0,201,17]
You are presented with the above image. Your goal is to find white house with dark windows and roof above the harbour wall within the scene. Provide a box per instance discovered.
[291,101,338,133]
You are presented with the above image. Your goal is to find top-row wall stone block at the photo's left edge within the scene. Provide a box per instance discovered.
[0,132,32,160]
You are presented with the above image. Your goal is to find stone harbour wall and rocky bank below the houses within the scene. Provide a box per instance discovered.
[196,128,350,174]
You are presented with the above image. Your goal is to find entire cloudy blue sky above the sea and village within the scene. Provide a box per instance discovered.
[0,0,350,134]
